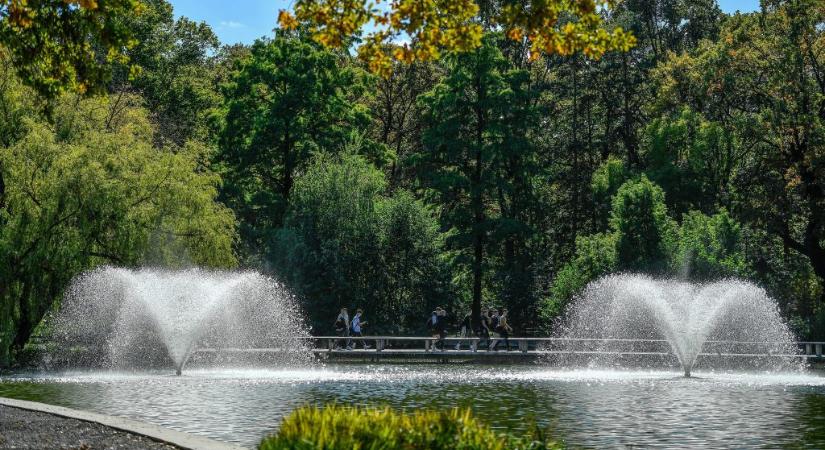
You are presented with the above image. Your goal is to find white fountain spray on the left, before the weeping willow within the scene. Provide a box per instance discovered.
[54,267,310,375]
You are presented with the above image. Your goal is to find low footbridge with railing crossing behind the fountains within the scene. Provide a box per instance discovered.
[195,336,825,362]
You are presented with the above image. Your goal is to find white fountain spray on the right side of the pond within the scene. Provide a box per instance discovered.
[558,274,802,377]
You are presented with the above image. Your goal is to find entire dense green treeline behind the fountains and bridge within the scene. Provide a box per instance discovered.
[0,0,825,361]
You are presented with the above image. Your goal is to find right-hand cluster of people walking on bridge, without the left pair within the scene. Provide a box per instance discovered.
[427,307,513,351]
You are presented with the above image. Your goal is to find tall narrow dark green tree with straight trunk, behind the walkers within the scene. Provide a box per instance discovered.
[414,38,535,326]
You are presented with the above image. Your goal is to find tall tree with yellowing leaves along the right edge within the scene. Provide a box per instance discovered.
[654,0,825,279]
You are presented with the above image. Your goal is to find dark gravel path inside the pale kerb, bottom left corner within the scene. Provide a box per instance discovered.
[0,405,179,450]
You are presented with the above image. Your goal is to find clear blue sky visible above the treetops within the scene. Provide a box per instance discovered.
[170,0,759,44]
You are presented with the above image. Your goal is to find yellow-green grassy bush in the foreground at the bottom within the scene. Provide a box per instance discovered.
[259,406,560,450]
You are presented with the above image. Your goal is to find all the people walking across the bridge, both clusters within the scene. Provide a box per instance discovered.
[334,306,513,351]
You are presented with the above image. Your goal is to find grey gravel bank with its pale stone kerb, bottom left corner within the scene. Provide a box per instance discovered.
[0,397,241,450]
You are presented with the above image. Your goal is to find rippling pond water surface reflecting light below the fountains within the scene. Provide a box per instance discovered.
[0,365,825,448]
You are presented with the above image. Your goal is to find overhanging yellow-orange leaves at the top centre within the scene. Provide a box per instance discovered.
[278,0,636,76]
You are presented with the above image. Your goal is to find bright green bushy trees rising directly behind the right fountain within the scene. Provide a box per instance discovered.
[541,177,752,323]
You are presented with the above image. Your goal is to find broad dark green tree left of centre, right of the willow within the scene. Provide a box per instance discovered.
[217,35,376,260]
